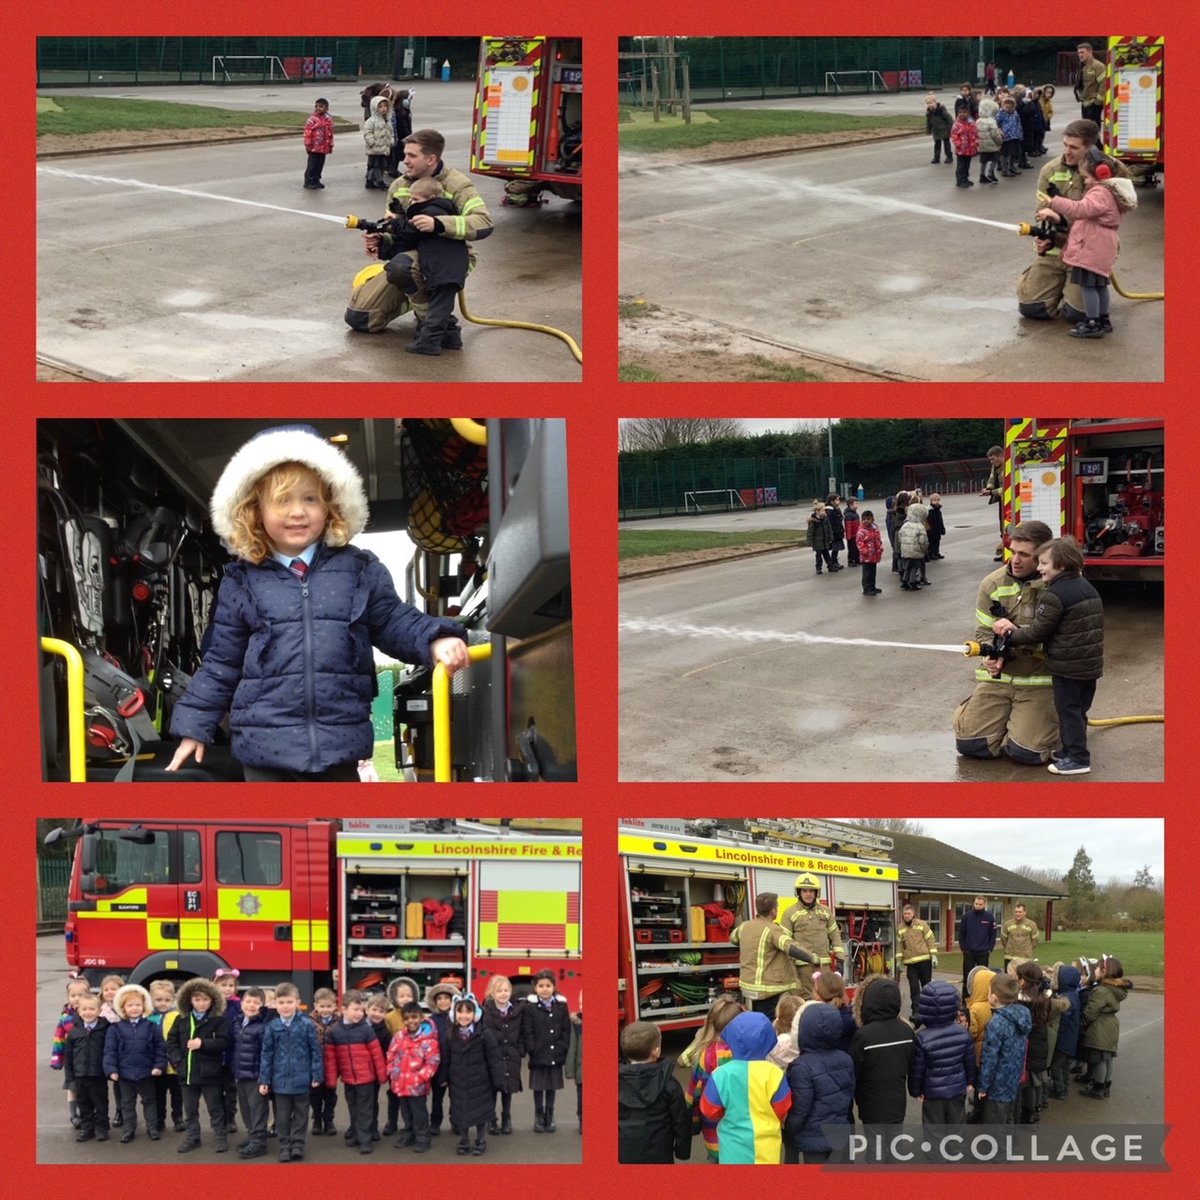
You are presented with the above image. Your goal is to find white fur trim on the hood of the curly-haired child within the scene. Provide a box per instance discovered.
[209,425,368,545]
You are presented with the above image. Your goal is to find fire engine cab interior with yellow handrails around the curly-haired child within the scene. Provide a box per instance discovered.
[37,418,576,782]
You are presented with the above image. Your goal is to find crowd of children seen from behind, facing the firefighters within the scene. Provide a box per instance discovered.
[618,956,1130,1163]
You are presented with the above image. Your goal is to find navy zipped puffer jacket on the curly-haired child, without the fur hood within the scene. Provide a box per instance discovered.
[170,546,466,773]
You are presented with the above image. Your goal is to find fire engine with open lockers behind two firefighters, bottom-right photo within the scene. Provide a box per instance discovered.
[618,817,900,1030]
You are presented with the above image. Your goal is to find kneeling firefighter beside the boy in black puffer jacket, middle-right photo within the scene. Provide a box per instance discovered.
[954,521,1058,766]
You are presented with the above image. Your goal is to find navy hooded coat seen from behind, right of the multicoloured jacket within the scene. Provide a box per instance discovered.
[784,1004,854,1151]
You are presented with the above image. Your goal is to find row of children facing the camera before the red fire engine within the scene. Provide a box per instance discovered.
[50,970,583,1163]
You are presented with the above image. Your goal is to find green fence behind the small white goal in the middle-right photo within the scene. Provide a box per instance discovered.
[619,457,842,521]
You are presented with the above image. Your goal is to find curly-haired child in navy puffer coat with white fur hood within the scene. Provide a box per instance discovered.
[167,426,468,782]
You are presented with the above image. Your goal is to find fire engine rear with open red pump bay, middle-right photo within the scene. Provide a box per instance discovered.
[1004,416,1165,582]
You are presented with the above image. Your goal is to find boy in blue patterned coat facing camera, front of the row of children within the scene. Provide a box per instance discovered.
[258,980,325,1163]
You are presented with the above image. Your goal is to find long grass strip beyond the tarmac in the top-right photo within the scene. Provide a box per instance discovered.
[619,108,925,150]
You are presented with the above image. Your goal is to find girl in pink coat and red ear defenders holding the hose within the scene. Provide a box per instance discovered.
[1038,146,1138,337]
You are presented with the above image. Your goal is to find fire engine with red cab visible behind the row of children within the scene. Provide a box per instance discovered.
[48,818,583,1006]
